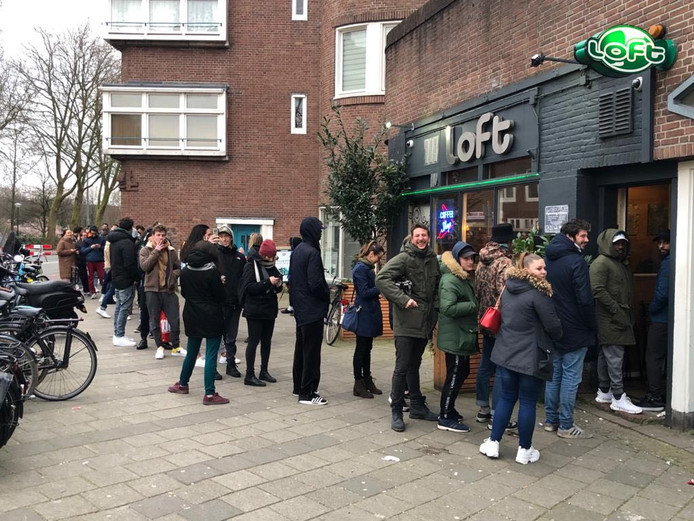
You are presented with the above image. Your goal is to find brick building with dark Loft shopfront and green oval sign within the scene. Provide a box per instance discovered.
[385,0,694,428]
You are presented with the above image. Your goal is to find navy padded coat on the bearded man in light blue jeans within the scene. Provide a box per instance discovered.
[545,234,598,353]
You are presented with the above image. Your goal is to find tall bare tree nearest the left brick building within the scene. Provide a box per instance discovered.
[20,25,119,240]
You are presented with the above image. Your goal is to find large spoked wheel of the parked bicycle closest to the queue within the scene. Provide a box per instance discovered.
[29,326,96,401]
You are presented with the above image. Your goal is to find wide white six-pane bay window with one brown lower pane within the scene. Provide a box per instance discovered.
[102,86,226,156]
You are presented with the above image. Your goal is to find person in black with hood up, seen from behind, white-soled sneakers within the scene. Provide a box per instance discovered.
[289,217,330,405]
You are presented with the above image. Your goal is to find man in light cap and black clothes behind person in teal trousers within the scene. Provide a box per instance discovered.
[217,224,246,378]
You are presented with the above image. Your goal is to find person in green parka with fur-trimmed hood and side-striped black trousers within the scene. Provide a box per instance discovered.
[437,241,479,432]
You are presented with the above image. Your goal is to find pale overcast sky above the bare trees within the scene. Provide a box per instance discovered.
[0,0,108,57]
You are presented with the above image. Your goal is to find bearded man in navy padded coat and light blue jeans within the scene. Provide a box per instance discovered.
[544,219,598,438]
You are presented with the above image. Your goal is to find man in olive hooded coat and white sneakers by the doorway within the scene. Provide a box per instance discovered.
[590,228,642,414]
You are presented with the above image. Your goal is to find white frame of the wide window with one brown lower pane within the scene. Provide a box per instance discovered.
[101,85,227,157]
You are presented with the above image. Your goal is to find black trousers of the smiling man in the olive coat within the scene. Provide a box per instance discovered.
[390,336,428,408]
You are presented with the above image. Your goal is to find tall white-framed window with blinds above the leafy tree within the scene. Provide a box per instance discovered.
[335,22,398,98]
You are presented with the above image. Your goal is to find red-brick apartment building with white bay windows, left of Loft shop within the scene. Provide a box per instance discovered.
[103,0,423,275]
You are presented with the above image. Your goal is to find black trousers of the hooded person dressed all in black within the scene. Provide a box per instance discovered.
[292,320,323,399]
